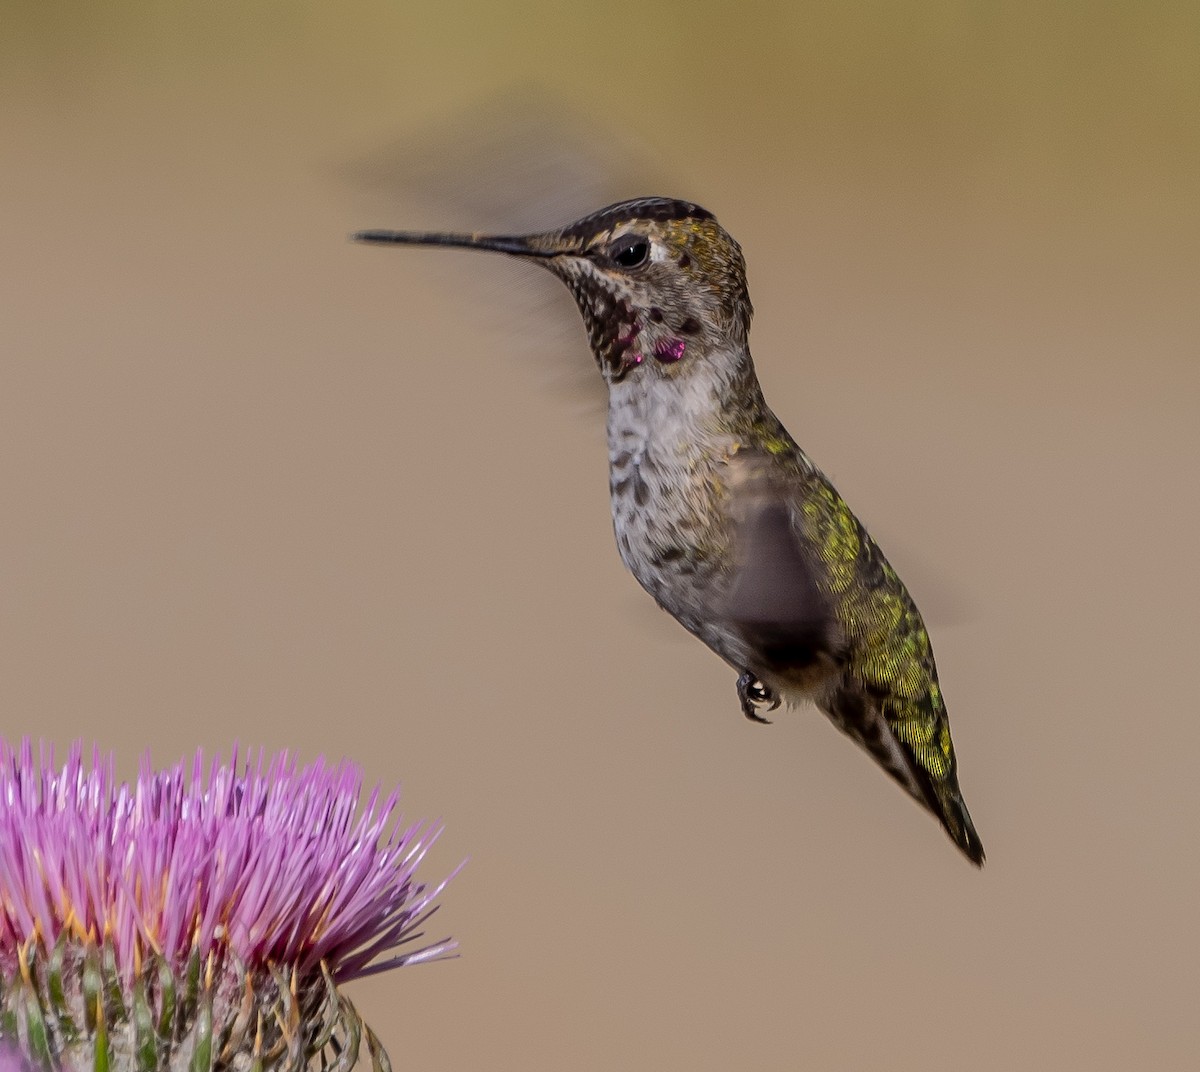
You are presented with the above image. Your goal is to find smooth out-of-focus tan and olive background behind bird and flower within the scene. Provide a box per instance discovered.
[0,0,1200,1072]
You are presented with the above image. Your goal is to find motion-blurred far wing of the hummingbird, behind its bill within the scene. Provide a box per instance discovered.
[338,86,664,411]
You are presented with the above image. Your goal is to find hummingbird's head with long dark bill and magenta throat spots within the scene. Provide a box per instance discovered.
[355,197,752,384]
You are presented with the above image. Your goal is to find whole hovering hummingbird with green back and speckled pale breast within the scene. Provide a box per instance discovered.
[354,197,984,866]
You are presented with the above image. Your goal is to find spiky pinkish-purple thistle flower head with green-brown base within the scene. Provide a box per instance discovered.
[0,739,454,1072]
